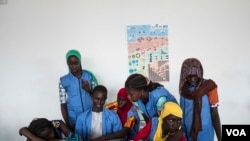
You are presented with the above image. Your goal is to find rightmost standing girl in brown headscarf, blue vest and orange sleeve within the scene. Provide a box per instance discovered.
[179,58,221,141]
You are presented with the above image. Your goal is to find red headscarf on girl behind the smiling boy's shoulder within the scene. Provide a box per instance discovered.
[117,88,132,125]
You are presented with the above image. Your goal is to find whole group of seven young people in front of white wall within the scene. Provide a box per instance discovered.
[19,50,221,141]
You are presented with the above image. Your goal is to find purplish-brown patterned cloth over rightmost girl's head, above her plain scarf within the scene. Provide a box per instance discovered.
[179,58,203,91]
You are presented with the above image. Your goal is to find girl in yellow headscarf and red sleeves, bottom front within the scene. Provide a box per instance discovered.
[133,102,185,141]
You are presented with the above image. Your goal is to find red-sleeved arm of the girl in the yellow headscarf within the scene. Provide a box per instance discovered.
[133,120,152,141]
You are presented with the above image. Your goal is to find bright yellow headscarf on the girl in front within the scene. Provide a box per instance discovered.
[154,101,182,141]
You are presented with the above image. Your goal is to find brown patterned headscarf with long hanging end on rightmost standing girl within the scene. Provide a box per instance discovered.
[179,58,217,141]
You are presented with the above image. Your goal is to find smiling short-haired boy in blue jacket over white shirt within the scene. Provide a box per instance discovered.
[75,85,122,141]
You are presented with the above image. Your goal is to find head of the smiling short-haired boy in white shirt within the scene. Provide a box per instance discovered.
[92,85,108,112]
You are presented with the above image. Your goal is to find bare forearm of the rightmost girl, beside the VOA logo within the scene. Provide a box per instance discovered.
[211,107,222,141]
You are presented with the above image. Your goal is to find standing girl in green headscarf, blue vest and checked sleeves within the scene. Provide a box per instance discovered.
[59,49,97,131]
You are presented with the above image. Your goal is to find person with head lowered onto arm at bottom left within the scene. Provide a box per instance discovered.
[19,118,71,141]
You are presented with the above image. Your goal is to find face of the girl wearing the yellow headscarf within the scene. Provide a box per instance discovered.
[162,115,181,133]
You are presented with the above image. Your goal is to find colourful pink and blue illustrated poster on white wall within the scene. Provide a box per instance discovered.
[127,24,169,82]
